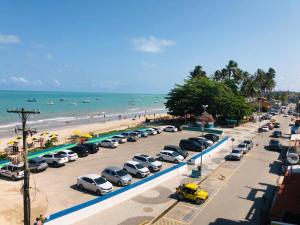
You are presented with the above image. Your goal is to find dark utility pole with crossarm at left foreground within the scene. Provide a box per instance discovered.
[7,108,40,225]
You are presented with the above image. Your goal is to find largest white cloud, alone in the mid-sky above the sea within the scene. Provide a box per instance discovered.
[132,36,176,53]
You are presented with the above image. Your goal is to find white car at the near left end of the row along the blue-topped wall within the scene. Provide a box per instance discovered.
[77,174,112,195]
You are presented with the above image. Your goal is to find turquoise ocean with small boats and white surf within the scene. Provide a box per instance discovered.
[0,91,166,136]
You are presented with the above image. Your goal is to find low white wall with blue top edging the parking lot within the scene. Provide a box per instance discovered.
[46,137,228,225]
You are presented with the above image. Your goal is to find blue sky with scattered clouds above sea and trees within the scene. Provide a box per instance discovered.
[0,0,300,93]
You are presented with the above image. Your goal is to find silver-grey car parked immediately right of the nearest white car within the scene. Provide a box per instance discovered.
[102,167,132,186]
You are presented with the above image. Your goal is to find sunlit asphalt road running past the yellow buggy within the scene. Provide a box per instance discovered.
[190,116,290,225]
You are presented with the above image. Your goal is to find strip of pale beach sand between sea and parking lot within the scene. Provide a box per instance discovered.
[0,114,167,152]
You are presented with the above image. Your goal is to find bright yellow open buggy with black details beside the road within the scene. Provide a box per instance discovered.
[176,183,209,205]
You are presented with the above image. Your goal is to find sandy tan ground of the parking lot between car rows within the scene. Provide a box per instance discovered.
[0,131,206,224]
